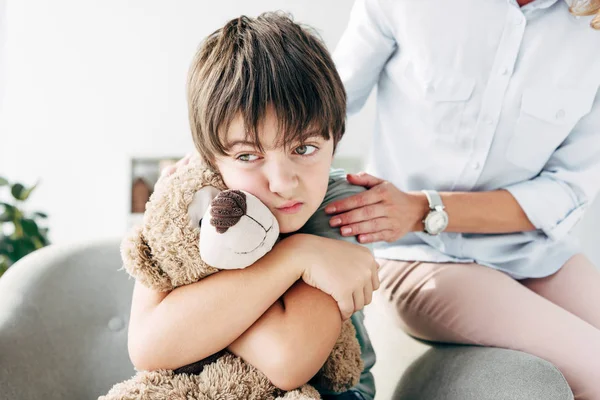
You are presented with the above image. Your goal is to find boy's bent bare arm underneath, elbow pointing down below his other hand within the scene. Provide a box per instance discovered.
[229,281,342,390]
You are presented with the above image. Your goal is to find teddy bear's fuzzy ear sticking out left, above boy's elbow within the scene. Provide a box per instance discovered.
[121,227,173,292]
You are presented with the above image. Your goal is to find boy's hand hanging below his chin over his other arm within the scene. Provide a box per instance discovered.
[286,234,379,320]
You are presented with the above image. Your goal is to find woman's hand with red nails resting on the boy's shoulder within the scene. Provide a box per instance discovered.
[325,173,429,243]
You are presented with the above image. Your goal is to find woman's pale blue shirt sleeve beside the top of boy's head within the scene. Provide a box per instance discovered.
[333,0,396,114]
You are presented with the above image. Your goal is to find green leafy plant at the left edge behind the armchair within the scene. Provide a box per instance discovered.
[0,177,50,276]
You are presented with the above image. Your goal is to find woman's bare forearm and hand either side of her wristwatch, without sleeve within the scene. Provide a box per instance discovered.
[326,174,535,243]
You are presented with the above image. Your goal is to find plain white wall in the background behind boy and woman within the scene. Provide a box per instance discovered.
[0,0,600,265]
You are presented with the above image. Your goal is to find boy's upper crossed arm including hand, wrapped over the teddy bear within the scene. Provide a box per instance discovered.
[129,234,379,369]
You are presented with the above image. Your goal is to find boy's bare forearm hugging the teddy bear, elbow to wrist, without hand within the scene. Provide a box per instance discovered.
[128,234,301,370]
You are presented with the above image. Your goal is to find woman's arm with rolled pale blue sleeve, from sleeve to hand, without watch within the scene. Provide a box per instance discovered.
[328,85,600,243]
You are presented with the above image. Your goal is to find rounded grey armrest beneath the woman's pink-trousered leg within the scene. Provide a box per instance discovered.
[393,345,573,400]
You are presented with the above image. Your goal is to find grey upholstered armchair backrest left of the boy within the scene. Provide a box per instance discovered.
[0,240,135,400]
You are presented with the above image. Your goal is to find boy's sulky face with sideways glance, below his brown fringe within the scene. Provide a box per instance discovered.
[215,109,333,233]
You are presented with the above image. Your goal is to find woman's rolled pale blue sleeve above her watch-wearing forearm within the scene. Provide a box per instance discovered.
[505,89,600,240]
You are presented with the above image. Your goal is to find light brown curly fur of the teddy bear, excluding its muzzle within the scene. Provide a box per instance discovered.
[99,157,363,400]
